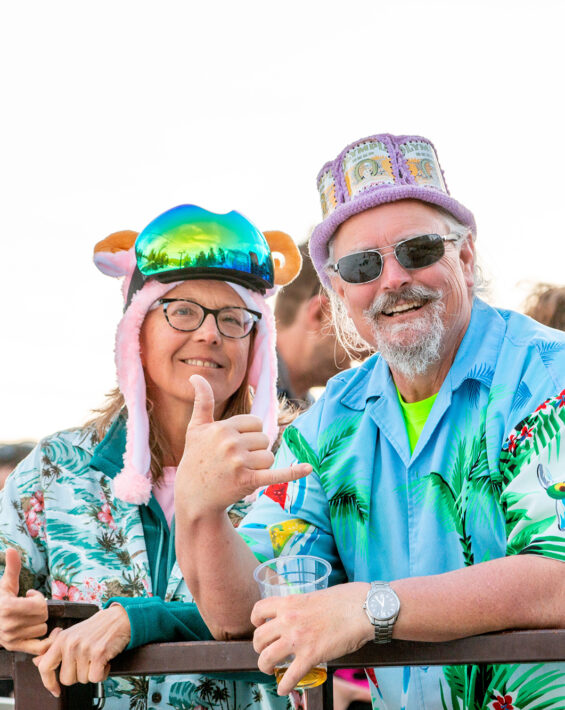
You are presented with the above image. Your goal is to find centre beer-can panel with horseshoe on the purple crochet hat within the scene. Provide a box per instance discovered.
[343,141,395,197]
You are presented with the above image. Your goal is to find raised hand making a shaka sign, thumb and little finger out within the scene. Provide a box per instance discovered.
[175,375,312,514]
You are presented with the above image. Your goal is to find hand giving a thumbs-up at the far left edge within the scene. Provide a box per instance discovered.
[0,547,48,655]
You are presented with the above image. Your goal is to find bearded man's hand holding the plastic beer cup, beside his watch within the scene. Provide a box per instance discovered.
[251,582,374,695]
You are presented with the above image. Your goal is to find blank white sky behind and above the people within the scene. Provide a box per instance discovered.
[0,0,565,440]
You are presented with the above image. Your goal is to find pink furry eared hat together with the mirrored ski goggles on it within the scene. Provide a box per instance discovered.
[94,205,301,505]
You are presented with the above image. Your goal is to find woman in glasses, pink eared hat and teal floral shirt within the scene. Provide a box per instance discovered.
[0,205,300,709]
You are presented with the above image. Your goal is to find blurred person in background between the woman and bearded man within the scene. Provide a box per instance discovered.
[275,244,356,409]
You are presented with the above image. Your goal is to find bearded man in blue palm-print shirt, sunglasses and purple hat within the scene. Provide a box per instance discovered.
[176,134,565,710]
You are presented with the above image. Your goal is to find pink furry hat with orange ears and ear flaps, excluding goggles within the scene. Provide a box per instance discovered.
[94,213,300,505]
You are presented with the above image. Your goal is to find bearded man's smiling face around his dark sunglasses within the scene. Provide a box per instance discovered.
[331,200,474,375]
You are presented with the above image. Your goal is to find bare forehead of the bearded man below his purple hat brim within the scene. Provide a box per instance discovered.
[329,200,449,261]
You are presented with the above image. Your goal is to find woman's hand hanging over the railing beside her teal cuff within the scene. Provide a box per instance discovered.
[33,604,131,698]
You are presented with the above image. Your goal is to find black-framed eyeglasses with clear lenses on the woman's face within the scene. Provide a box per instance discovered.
[158,298,261,338]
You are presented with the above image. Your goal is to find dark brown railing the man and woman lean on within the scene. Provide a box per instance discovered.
[0,602,565,710]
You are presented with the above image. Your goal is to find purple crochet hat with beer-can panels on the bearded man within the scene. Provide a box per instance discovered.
[310,133,476,286]
